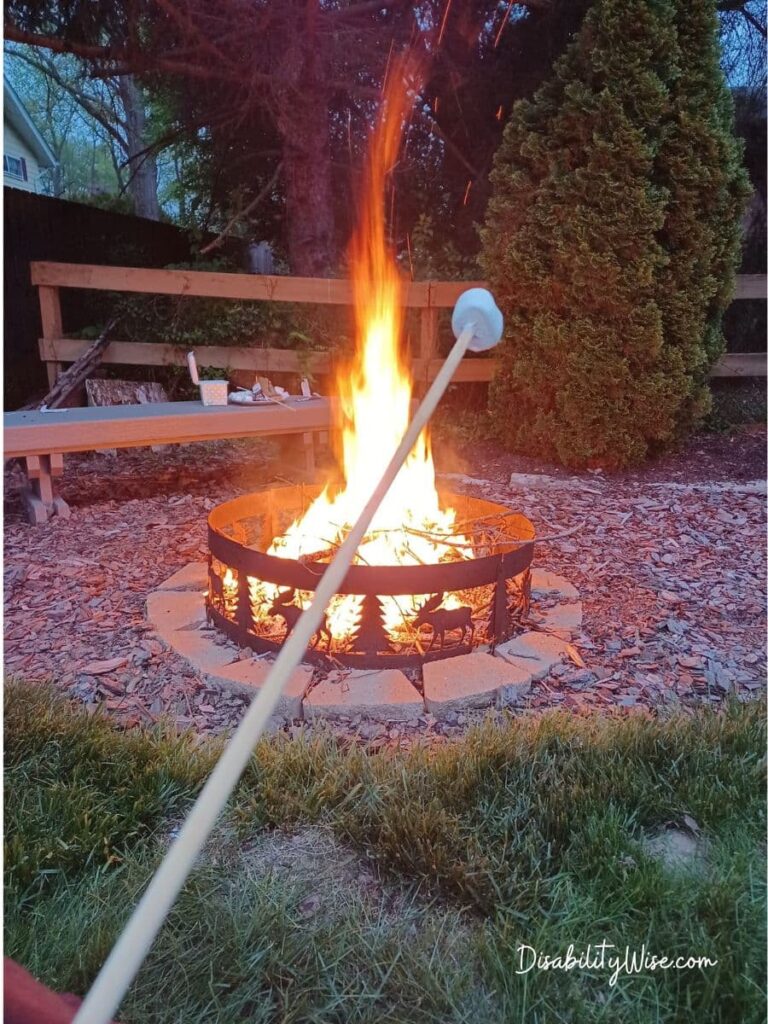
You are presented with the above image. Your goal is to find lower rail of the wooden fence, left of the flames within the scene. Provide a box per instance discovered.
[38,338,333,375]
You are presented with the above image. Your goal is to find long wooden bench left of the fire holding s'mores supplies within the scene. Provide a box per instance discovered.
[3,398,333,523]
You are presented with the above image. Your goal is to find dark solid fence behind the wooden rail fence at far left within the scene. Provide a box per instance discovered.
[3,188,204,409]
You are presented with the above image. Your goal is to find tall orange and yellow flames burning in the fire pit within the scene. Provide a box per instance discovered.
[249,57,471,639]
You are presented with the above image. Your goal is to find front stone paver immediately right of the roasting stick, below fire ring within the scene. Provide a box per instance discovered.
[304,669,424,722]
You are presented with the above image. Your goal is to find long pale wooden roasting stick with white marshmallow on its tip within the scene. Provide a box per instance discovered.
[73,288,503,1024]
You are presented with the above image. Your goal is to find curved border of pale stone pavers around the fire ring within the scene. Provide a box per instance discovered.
[146,562,582,723]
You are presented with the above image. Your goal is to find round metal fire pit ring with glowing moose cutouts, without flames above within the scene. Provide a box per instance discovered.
[206,486,535,668]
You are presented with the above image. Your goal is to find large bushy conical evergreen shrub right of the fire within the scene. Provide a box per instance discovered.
[482,0,745,466]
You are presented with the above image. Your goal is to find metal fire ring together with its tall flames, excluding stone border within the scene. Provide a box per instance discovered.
[201,69,534,669]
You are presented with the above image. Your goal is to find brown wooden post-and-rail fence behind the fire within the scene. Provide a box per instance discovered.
[32,262,767,385]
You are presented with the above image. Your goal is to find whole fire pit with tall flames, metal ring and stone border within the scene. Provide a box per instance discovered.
[147,59,582,723]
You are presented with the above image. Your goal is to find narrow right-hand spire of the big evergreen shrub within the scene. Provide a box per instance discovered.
[656,0,750,430]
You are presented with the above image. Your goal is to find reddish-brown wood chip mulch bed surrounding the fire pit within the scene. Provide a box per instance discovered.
[4,431,766,746]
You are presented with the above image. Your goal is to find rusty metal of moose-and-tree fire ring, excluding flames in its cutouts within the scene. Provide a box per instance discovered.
[206,484,535,668]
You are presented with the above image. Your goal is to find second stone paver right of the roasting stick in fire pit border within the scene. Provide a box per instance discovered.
[424,652,530,718]
